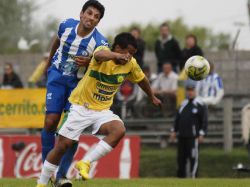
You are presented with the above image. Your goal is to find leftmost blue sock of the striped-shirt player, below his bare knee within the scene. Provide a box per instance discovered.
[41,129,55,162]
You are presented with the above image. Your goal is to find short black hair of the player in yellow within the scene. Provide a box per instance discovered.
[112,32,137,50]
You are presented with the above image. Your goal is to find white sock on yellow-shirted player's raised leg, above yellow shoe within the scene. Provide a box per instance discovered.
[83,140,113,162]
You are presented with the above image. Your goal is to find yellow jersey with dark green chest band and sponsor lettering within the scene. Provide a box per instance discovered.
[69,46,145,111]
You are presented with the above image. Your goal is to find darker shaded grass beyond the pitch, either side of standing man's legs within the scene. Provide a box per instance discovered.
[140,146,250,178]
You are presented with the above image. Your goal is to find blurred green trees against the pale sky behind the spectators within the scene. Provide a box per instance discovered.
[0,0,232,54]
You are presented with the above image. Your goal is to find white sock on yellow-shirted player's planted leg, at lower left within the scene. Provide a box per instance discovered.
[37,160,58,185]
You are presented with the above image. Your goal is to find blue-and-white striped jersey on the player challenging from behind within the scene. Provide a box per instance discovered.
[52,19,108,76]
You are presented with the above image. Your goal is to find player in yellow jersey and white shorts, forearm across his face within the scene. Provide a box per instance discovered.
[38,33,161,187]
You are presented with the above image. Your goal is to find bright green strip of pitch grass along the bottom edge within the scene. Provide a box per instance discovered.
[0,178,250,187]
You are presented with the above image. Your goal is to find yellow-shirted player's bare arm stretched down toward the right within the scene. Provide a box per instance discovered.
[138,77,161,106]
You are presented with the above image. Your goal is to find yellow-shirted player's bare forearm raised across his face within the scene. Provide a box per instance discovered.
[94,49,132,64]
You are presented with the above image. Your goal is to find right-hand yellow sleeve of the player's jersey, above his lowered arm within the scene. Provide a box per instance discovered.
[127,58,145,83]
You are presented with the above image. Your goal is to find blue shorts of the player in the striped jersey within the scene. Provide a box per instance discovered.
[46,65,78,114]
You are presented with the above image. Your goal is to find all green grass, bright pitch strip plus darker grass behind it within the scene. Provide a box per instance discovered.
[0,147,250,187]
